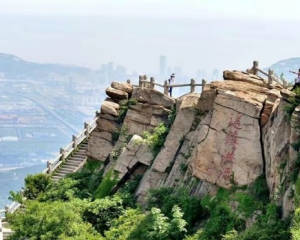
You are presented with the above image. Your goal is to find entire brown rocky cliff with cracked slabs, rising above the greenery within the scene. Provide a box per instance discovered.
[88,71,300,216]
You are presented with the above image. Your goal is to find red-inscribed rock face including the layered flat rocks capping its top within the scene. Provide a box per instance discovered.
[190,71,289,189]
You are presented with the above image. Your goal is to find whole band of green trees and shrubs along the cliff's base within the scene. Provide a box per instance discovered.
[7,164,300,240]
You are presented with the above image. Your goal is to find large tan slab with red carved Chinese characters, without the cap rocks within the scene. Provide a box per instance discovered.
[191,90,263,188]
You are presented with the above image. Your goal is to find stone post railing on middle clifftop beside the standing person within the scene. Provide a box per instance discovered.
[127,75,206,95]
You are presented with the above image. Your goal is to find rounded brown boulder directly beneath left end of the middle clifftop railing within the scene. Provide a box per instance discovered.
[132,88,175,108]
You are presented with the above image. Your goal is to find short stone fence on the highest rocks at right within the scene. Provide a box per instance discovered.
[247,61,290,88]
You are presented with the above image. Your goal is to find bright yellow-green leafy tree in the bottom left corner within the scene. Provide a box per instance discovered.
[7,200,103,240]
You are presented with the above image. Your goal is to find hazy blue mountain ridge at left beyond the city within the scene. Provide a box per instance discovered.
[0,53,91,80]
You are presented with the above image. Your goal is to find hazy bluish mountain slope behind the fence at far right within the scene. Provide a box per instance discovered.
[266,57,300,82]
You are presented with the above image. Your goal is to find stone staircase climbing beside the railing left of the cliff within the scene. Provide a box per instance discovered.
[52,142,87,182]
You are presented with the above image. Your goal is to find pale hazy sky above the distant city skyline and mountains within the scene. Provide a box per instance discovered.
[0,0,300,75]
